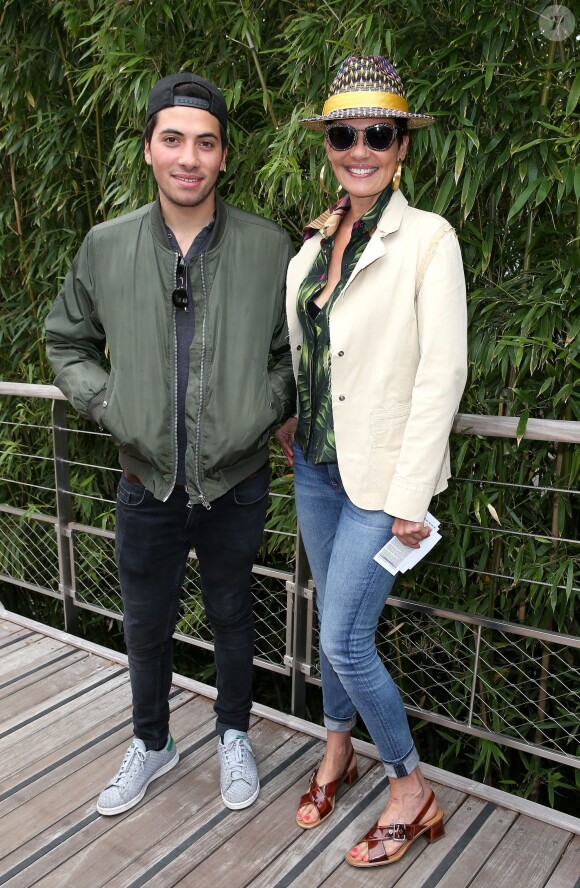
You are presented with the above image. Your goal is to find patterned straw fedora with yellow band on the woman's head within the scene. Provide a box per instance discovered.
[300,56,435,130]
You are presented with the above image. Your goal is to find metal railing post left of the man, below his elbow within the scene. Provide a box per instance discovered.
[52,401,78,634]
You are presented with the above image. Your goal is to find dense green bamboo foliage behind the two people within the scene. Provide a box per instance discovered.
[0,0,580,804]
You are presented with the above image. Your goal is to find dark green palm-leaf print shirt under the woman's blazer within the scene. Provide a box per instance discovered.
[295,185,392,463]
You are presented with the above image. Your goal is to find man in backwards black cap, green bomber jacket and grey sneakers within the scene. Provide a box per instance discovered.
[46,73,294,814]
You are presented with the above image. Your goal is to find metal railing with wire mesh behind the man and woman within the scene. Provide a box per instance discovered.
[0,383,580,767]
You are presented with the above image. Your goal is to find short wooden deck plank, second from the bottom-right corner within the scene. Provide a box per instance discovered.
[472,815,570,888]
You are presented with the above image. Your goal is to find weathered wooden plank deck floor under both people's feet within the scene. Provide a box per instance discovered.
[0,610,580,888]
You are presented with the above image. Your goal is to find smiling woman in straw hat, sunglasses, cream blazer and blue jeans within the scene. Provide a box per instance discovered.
[278,56,467,867]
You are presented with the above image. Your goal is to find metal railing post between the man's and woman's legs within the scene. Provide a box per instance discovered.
[289,527,314,718]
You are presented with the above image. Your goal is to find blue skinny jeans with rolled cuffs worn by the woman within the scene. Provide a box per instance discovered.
[294,445,419,777]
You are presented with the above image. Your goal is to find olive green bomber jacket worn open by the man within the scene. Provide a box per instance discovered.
[45,196,295,504]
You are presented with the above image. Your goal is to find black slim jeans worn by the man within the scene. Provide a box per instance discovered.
[115,464,269,749]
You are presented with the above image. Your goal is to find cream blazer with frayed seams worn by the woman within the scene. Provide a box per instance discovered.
[287,191,467,521]
